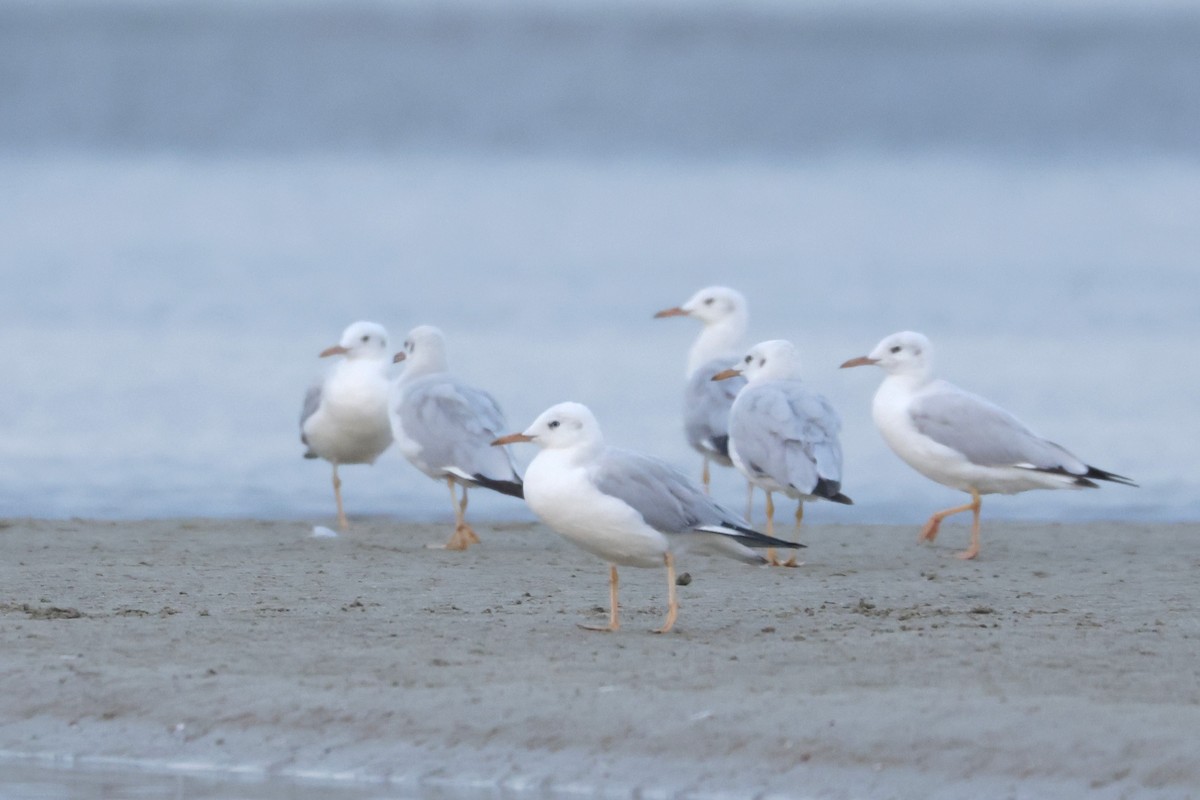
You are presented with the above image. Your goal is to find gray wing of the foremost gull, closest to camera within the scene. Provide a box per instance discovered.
[592,447,745,534]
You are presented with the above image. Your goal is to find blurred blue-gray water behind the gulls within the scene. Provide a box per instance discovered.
[0,0,1200,525]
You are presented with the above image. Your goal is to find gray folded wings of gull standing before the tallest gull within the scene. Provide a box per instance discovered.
[730,380,841,494]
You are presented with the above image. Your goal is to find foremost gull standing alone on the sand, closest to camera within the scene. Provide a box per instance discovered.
[493,403,804,633]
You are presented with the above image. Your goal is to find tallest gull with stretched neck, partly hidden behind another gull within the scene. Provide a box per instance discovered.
[654,287,754,501]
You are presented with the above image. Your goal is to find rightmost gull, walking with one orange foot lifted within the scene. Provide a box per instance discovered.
[841,331,1136,559]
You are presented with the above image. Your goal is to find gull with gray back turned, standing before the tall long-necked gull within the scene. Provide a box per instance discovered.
[713,339,853,566]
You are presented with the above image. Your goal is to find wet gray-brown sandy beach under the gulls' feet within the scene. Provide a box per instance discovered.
[0,519,1200,798]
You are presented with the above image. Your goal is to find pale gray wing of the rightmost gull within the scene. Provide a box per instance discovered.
[908,381,1087,475]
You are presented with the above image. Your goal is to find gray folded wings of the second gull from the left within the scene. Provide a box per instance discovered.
[398,373,520,480]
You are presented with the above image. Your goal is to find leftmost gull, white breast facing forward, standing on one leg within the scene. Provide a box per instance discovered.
[300,321,391,531]
